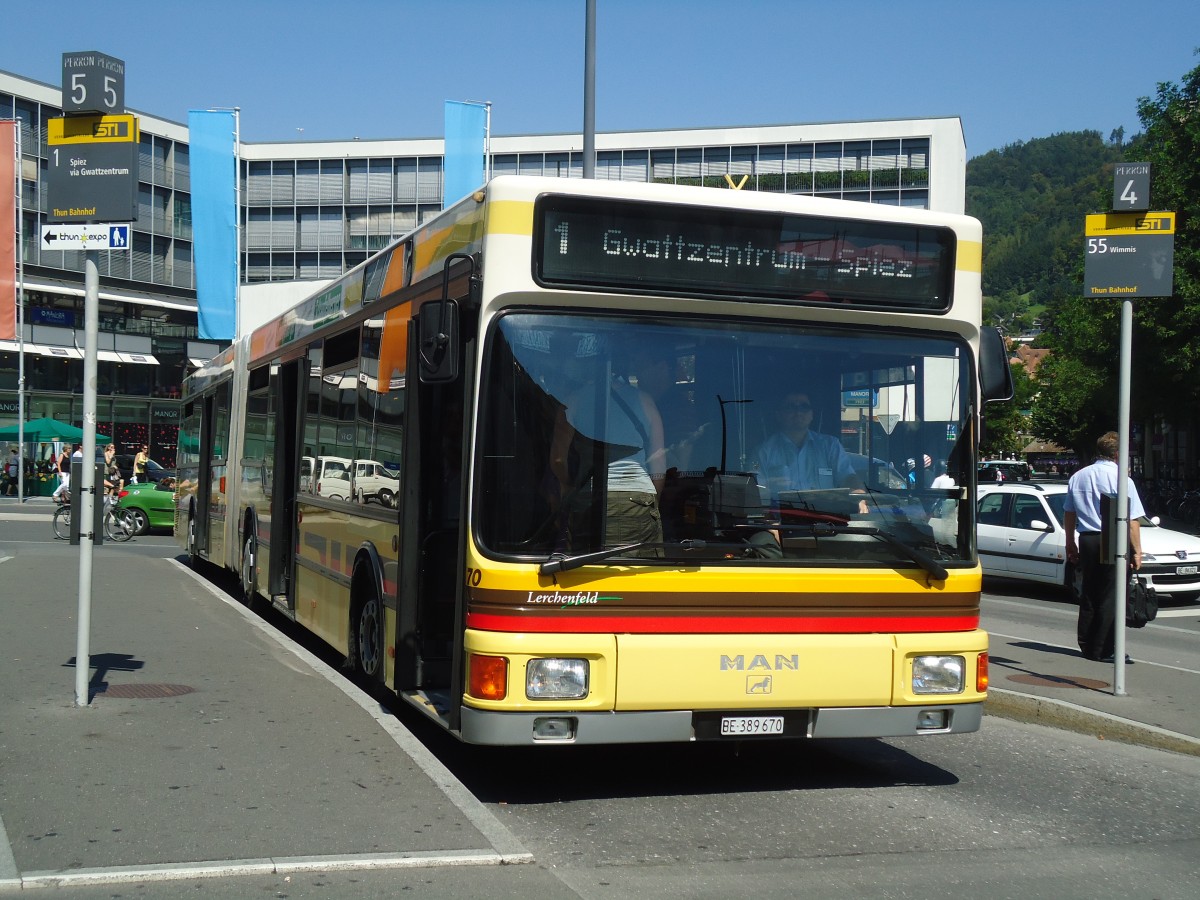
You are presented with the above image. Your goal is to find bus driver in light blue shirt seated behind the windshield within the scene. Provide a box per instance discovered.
[756,391,866,504]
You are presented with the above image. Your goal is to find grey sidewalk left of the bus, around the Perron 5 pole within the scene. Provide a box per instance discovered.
[0,498,539,894]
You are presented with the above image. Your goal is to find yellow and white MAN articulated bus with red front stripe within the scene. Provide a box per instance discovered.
[175,176,1012,745]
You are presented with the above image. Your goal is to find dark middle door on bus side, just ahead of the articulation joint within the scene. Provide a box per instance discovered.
[266,356,304,611]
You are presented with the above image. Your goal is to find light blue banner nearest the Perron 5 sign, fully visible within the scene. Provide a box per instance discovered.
[187,109,238,341]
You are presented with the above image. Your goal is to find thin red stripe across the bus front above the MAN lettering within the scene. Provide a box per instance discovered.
[467,612,979,635]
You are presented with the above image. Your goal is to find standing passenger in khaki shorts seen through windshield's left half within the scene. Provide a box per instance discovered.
[550,360,665,557]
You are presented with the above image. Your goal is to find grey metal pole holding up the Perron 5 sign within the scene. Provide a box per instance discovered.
[71,250,100,707]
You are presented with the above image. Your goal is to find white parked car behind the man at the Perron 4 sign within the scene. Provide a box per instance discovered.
[977,481,1200,601]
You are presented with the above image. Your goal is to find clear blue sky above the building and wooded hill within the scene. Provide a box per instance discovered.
[0,0,1200,157]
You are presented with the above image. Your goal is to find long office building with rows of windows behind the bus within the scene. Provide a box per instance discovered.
[0,72,966,475]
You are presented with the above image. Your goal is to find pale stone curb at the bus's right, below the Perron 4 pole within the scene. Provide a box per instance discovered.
[983,688,1200,756]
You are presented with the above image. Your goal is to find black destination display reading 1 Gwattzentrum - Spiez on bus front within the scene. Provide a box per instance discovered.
[535,196,954,312]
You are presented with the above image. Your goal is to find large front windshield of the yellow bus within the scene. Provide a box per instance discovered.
[473,312,973,568]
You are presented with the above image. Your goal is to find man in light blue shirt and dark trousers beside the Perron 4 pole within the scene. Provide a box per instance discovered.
[1062,431,1146,662]
